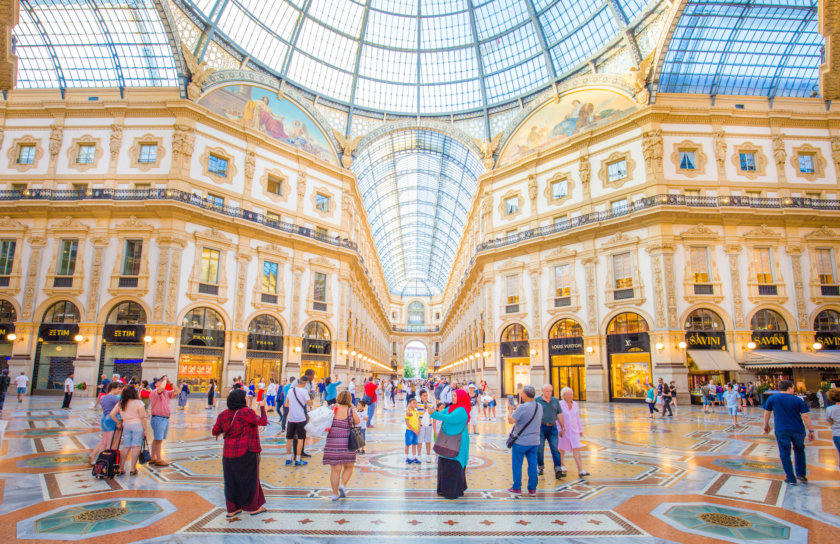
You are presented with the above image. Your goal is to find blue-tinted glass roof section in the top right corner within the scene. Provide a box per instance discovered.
[658,0,824,98]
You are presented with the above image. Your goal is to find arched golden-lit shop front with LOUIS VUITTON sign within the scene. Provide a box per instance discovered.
[548,319,586,400]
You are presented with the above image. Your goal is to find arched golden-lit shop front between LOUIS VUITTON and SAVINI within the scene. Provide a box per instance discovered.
[607,312,653,401]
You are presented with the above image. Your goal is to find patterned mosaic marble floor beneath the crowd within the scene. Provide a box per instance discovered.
[0,397,840,544]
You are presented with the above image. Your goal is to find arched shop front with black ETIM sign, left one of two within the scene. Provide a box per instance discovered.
[32,300,81,393]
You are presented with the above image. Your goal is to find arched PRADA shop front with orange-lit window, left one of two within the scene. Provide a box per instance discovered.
[178,308,225,393]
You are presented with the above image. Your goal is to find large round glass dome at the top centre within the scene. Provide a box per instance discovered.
[180,0,658,114]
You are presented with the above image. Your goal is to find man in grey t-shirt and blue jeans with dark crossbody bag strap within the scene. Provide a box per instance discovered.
[508,385,544,497]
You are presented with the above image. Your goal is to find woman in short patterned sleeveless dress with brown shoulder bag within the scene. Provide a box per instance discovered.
[324,391,361,501]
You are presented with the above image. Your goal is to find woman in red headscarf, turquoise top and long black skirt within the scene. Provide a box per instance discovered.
[432,389,470,500]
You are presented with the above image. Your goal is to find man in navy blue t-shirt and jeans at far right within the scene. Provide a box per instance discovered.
[764,380,814,485]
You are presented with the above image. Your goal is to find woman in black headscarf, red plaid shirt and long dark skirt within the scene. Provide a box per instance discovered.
[213,389,268,518]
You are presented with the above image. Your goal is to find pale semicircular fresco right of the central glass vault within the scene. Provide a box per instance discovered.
[499,89,637,164]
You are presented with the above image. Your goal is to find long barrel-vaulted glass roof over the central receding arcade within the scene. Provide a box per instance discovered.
[353,129,484,296]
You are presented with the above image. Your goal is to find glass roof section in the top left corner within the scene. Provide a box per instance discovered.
[12,0,178,90]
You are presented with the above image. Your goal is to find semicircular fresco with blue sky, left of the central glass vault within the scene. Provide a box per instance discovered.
[201,85,338,164]
